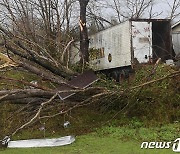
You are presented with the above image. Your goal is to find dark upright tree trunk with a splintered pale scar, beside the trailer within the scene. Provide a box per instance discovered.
[79,0,89,62]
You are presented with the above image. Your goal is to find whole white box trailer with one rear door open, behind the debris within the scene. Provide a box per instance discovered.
[71,19,172,80]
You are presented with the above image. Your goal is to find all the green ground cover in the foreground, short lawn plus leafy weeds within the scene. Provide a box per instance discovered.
[0,122,180,154]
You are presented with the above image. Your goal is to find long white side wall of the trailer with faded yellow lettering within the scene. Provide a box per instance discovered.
[89,21,131,70]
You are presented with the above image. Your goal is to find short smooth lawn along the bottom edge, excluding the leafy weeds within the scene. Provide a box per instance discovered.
[0,135,173,154]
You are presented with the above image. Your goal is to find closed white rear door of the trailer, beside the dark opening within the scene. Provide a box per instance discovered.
[132,21,152,63]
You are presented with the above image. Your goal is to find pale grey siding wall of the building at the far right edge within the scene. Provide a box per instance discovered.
[172,32,180,55]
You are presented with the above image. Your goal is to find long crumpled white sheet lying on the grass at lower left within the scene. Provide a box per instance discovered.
[7,136,75,148]
